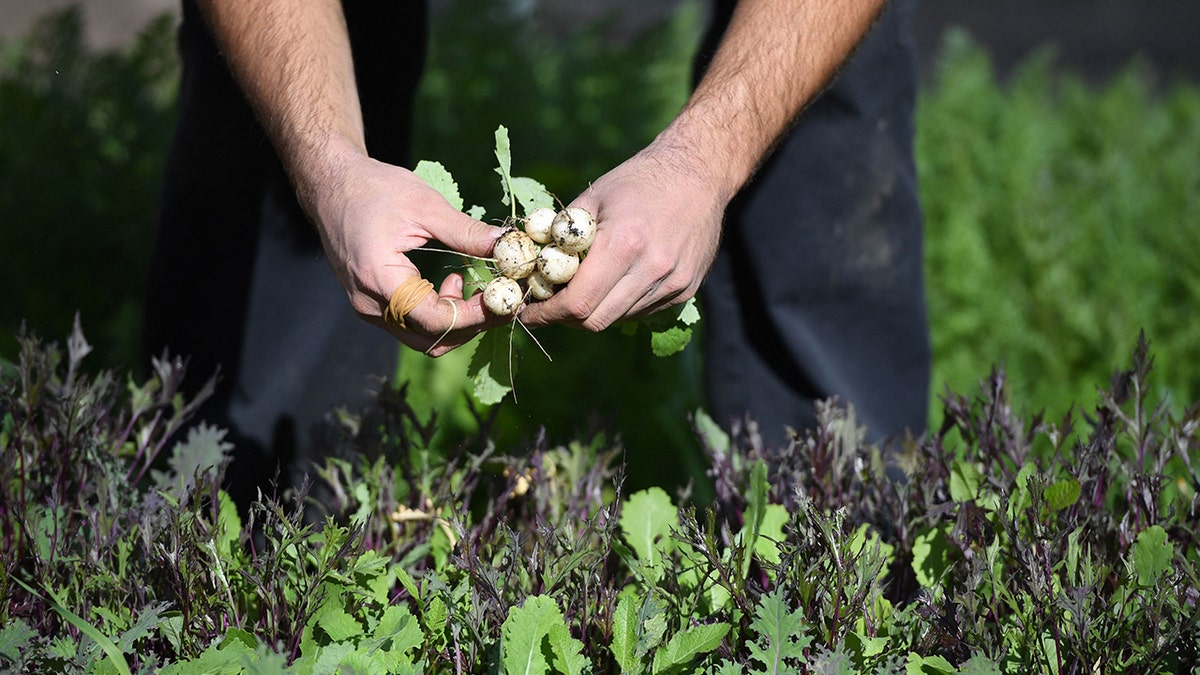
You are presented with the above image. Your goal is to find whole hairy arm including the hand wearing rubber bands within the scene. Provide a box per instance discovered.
[200,0,497,354]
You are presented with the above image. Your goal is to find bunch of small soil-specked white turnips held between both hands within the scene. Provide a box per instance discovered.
[484,207,596,316]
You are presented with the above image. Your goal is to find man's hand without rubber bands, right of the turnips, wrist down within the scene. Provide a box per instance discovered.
[521,143,727,330]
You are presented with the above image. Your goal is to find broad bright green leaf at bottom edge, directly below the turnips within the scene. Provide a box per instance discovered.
[500,596,583,675]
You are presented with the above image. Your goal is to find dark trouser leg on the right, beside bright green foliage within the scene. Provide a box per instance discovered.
[697,0,930,446]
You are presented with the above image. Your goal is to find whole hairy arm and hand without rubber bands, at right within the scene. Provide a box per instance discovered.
[522,0,886,330]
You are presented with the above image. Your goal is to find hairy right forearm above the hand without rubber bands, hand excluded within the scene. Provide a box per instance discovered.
[658,0,887,201]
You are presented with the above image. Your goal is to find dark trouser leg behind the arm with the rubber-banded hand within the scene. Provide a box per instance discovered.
[143,0,427,503]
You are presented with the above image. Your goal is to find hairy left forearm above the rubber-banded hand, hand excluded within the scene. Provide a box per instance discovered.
[200,0,366,216]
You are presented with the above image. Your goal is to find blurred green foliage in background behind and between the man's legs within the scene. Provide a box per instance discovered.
[0,0,1200,456]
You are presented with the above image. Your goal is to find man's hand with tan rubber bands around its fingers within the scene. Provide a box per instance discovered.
[312,139,504,356]
